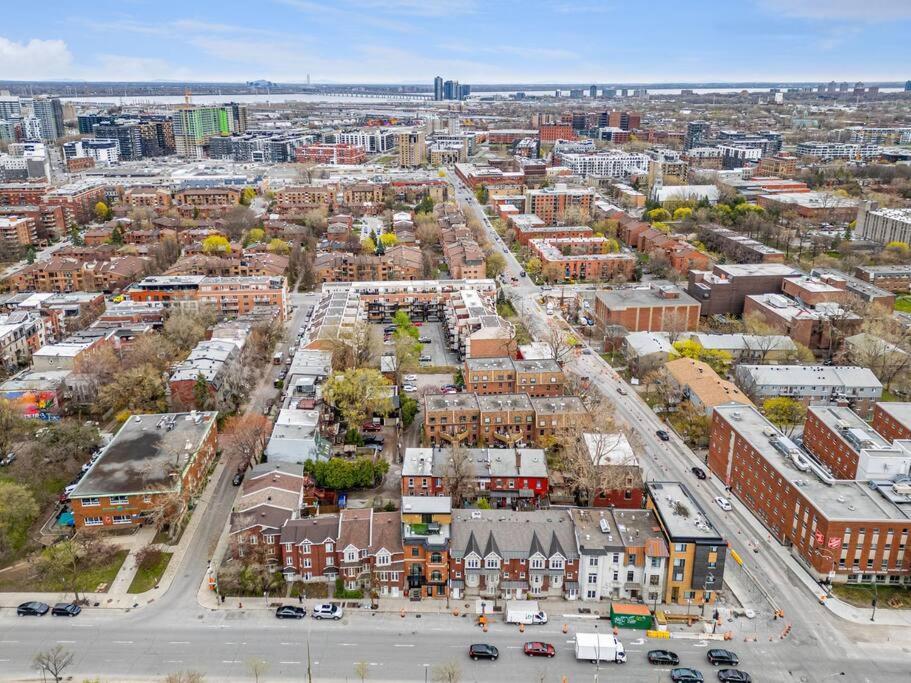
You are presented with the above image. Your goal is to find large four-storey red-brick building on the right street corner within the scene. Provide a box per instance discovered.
[708,406,911,585]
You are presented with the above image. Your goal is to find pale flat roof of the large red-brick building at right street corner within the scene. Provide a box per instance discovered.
[715,405,908,520]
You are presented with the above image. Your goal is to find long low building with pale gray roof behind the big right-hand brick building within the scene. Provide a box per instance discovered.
[734,365,883,417]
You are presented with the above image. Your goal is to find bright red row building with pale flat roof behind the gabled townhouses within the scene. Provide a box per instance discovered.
[402,448,549,509]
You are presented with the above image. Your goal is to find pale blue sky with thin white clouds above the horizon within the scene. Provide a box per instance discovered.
[0,0,911,85]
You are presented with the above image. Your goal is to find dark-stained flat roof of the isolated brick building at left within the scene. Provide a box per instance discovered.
[71,411,218,498]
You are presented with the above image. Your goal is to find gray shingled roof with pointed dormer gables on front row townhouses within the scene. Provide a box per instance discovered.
[450,510,579,560]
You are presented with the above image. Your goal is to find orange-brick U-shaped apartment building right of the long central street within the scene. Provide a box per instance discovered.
[528,237,636,282]
